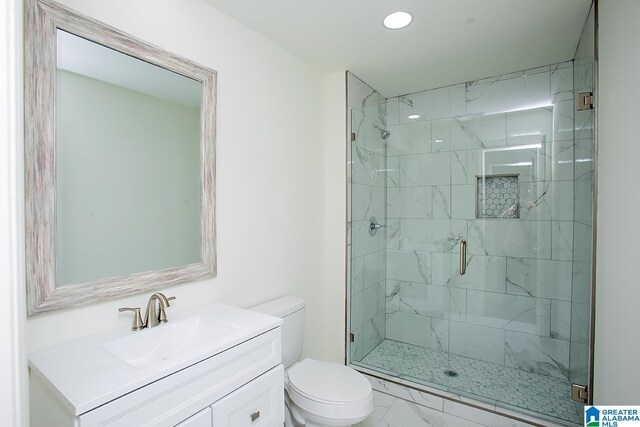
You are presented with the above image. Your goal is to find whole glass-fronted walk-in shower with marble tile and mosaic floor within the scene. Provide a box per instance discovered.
[347,16,594,425]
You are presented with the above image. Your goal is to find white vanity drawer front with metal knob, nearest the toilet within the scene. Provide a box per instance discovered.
[211,365,284,427]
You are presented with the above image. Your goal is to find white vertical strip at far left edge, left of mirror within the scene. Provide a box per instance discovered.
[0,0,28,426]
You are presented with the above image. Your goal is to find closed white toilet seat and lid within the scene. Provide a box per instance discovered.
[286,359,373,421]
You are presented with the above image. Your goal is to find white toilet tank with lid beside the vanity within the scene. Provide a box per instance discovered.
[250,296,304,369]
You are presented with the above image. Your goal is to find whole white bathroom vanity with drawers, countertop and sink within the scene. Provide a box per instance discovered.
[29,304,284,427]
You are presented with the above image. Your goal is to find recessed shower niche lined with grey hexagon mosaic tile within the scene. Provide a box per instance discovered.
[476,175,520,219]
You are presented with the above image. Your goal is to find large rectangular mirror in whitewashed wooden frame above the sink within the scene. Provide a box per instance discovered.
[25,0,216,315]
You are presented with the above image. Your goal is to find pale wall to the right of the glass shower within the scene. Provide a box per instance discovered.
[594,0,640,405]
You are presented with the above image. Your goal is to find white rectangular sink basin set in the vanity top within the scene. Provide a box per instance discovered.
[103,316,241,368]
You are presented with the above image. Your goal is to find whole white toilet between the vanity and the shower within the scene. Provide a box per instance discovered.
[251,296,373,427]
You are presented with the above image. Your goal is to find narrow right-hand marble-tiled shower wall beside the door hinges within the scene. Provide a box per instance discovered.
[570,3,595,385]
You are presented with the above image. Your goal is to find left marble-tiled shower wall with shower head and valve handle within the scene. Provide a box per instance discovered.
[347,73,387,361]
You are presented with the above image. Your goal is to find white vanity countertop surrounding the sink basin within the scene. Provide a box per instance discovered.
[29,303,282,415]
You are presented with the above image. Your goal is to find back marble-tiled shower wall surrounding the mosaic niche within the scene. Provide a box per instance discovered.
[385,62,587,379]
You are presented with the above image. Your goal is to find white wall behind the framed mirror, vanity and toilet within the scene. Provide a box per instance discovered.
[27,0,344,368]
